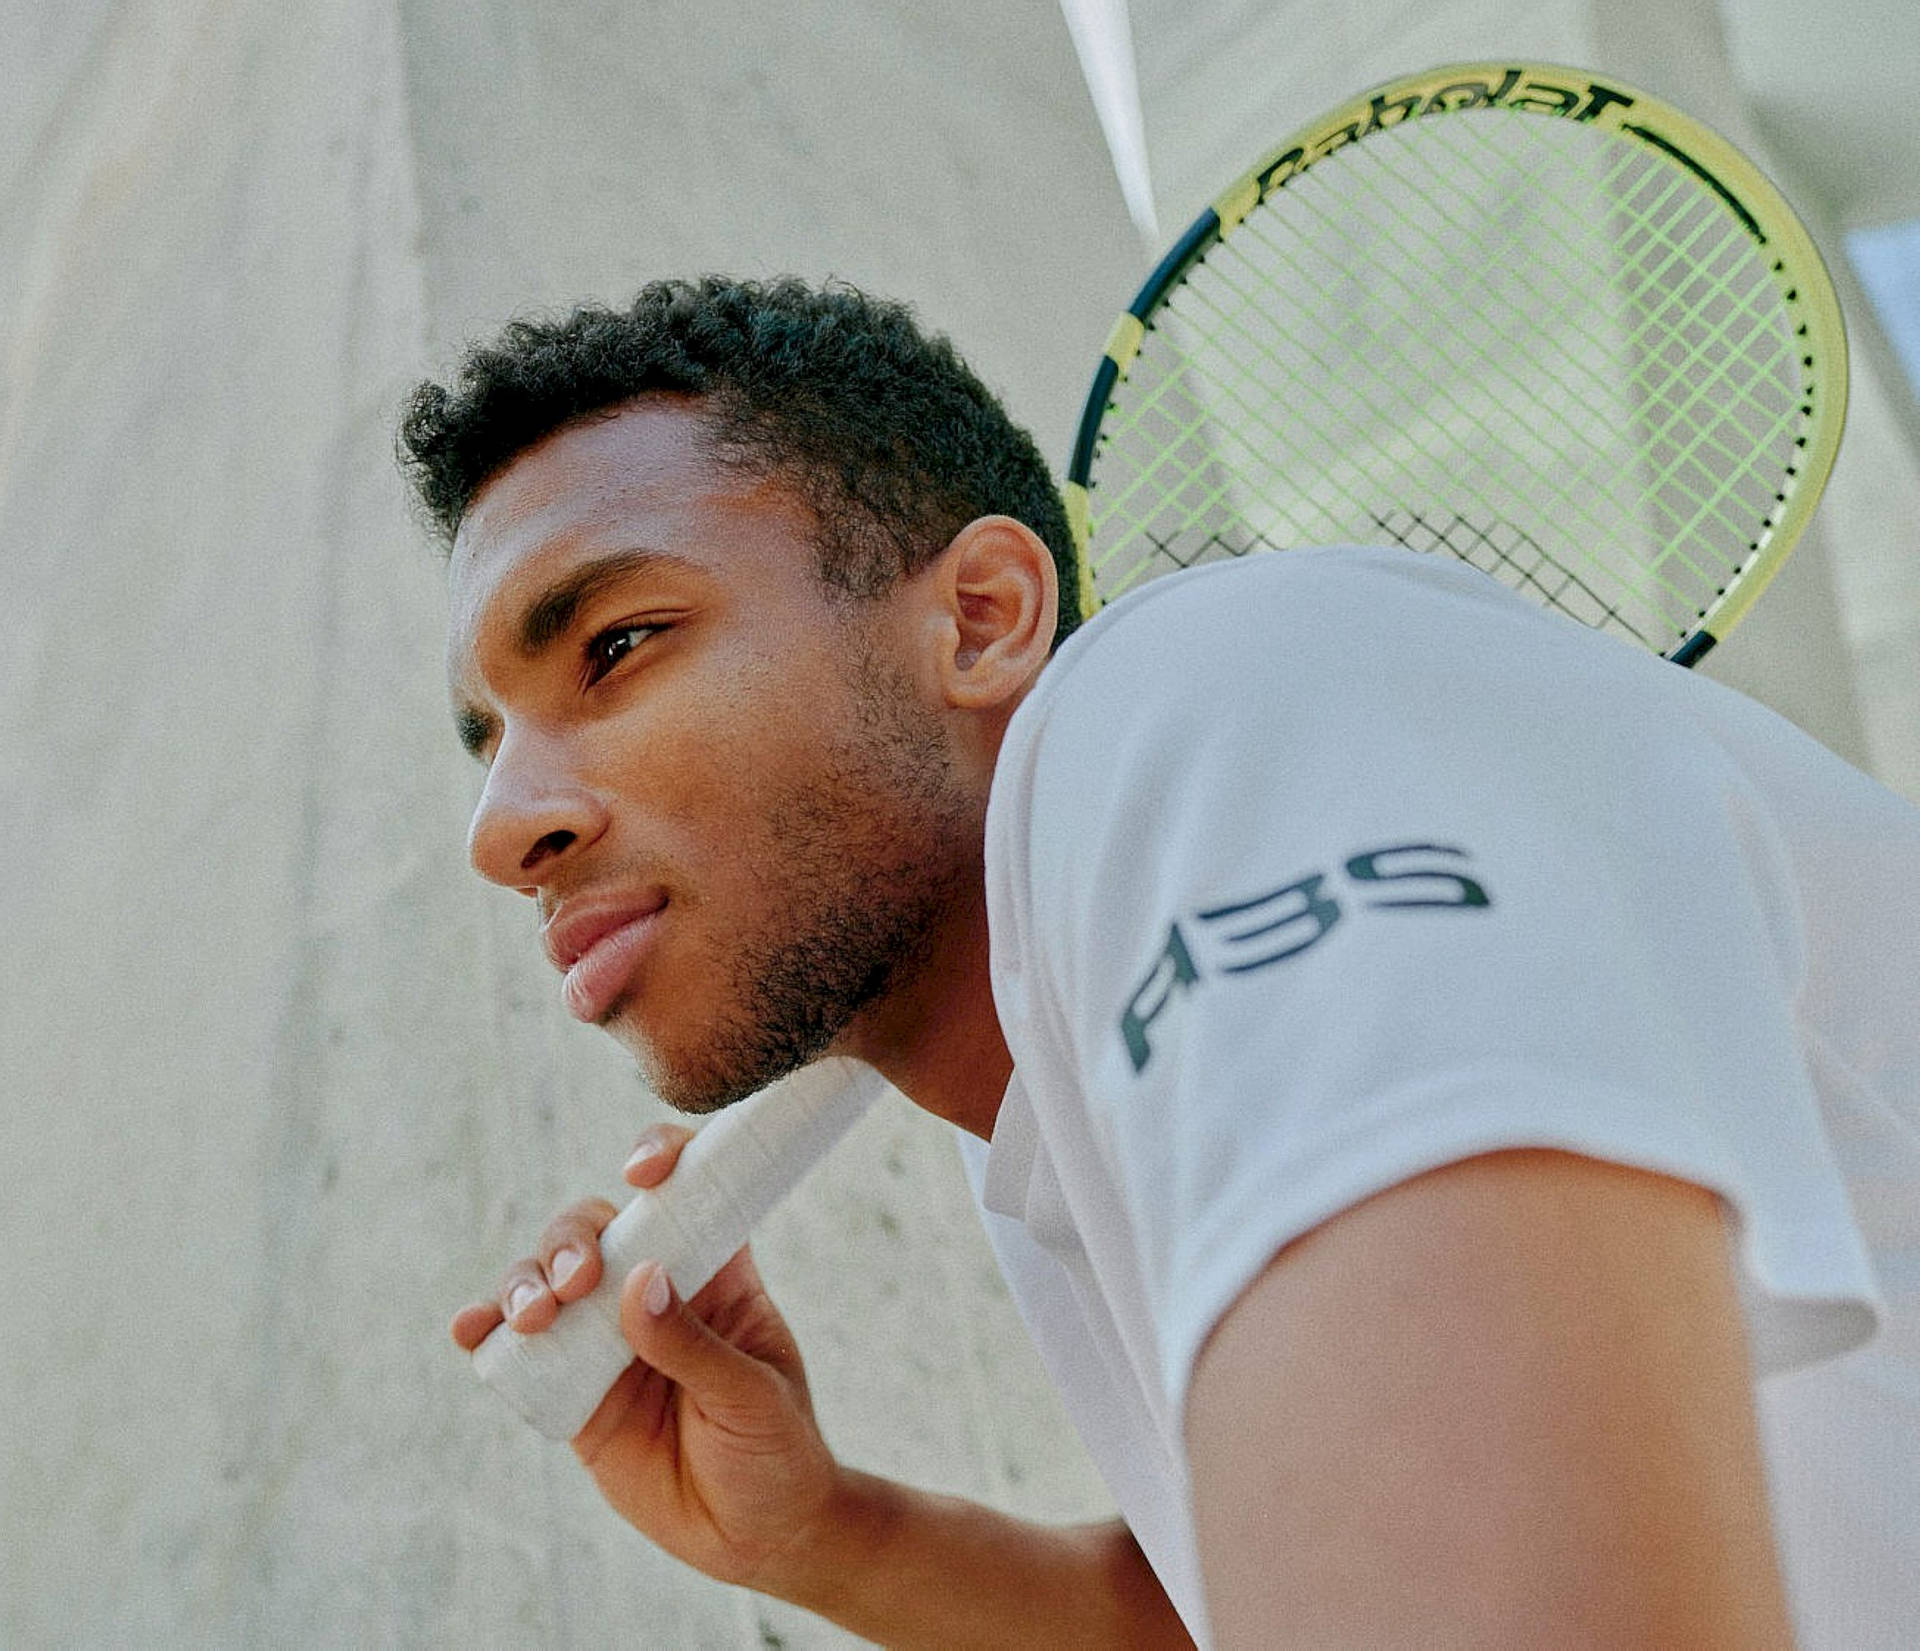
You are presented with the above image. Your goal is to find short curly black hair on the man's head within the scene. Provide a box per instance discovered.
[399,275,1081,641]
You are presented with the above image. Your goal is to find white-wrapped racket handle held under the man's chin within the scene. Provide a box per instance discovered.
[472,1058,887,1440]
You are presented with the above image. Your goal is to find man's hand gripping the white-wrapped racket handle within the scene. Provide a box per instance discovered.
[453,1125,841,1593]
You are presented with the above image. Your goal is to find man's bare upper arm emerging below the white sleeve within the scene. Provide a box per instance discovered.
[1187,1152,1791,1651]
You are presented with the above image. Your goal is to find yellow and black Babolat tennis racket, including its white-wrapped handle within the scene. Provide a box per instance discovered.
[474,63,1847,1438]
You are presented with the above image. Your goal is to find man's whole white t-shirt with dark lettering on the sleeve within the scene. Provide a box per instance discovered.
[964,549,1920,1651]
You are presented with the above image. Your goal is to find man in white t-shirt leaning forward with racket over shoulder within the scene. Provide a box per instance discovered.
[403,280,1920,1647]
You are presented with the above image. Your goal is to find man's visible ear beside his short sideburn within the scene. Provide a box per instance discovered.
[929,516,1060,712]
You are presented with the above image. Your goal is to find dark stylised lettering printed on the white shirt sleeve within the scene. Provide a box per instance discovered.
[1119,843,1494,1071]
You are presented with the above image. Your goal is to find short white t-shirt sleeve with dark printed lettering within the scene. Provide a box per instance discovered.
[991,553,1874,1413]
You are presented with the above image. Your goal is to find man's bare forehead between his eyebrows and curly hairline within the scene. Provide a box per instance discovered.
[447,395,812,656]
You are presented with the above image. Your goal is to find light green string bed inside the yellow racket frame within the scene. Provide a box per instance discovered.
[1092,111,1805,645]
